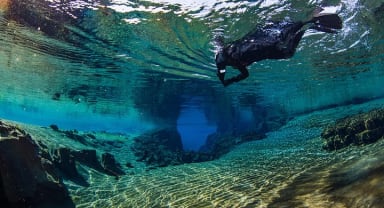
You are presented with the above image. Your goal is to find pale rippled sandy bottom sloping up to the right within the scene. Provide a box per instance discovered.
[13,100,384,208]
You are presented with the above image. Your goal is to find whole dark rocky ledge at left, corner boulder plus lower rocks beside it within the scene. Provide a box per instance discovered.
[0,121,125,208]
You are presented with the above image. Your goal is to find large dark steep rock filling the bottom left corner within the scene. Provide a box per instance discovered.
[0,121,75,207]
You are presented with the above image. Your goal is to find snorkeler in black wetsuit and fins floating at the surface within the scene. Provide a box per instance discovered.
[216,9,342,86]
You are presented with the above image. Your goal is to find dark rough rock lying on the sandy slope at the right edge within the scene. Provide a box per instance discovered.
[321,109,384,151]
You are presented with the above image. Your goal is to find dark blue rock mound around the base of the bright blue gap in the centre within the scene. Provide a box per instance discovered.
[132,128,265,168]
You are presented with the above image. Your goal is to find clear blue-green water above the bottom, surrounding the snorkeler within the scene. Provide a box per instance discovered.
[0,0,384,205]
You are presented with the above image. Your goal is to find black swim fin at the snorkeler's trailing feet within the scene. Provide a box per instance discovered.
[309,13,343,33]
